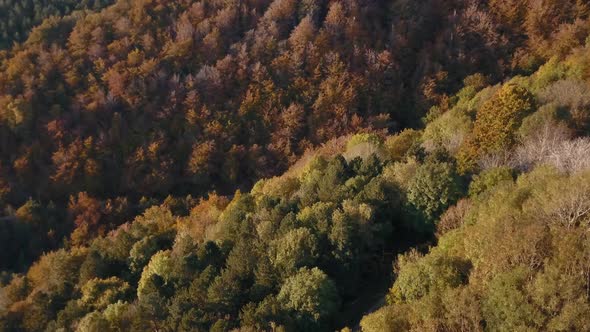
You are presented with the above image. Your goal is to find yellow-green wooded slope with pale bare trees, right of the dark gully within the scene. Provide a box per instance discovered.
[361,42,590,331]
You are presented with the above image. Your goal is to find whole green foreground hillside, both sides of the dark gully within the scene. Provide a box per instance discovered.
[2,44,590,331]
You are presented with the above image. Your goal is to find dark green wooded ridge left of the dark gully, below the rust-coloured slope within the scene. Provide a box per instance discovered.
[0,131,462,331]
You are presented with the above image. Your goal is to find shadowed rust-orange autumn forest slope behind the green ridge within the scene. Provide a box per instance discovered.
[0,0,588,270]
